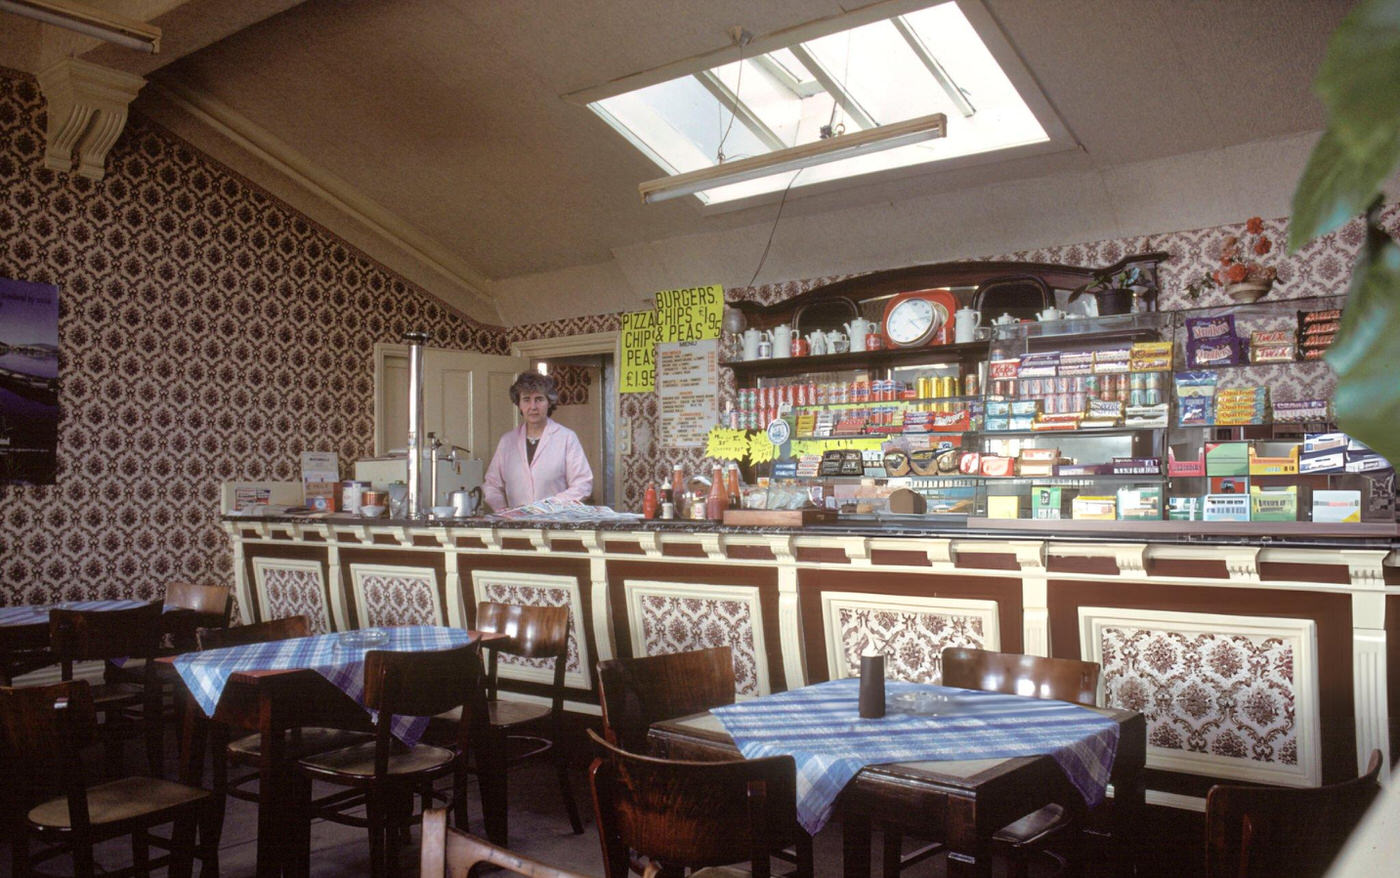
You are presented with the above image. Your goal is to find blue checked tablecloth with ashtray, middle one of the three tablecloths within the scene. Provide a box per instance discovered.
[175,625,472,745]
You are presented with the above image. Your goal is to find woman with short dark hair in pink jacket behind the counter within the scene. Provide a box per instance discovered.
[482,372,594,513]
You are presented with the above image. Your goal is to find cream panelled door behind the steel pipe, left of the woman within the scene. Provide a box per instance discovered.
[374,344,529,464]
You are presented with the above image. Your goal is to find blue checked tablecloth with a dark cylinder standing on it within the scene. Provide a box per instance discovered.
[710,678,1119,835]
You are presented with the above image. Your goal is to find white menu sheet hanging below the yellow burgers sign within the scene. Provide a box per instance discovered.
[657,339,720,448]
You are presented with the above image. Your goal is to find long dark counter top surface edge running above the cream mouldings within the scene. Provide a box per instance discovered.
[224,514,1400,548]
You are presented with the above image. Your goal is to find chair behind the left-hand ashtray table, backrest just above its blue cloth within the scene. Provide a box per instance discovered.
[197,616,370,861]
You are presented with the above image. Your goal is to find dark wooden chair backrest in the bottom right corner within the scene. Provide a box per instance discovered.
[1205,751,1382,878]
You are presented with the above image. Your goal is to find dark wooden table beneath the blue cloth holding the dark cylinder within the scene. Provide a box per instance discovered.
[648,709,1147,878]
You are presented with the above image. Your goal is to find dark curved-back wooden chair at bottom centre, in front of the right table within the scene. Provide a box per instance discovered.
[588,730,812,878]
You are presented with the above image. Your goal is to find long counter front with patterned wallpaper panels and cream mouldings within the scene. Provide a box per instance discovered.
[224,518,1400,808]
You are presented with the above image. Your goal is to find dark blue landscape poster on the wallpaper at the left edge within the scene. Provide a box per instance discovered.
[0,277,59,485]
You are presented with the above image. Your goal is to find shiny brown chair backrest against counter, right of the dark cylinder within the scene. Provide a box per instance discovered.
[944,647,1099,706]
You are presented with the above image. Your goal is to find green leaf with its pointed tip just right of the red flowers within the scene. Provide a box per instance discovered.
[1288,130,1400,252]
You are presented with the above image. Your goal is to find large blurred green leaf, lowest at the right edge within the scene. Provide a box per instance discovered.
[1327,224,1400,464]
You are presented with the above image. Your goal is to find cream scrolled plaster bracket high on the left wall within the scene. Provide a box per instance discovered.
[38,57,146,179]
